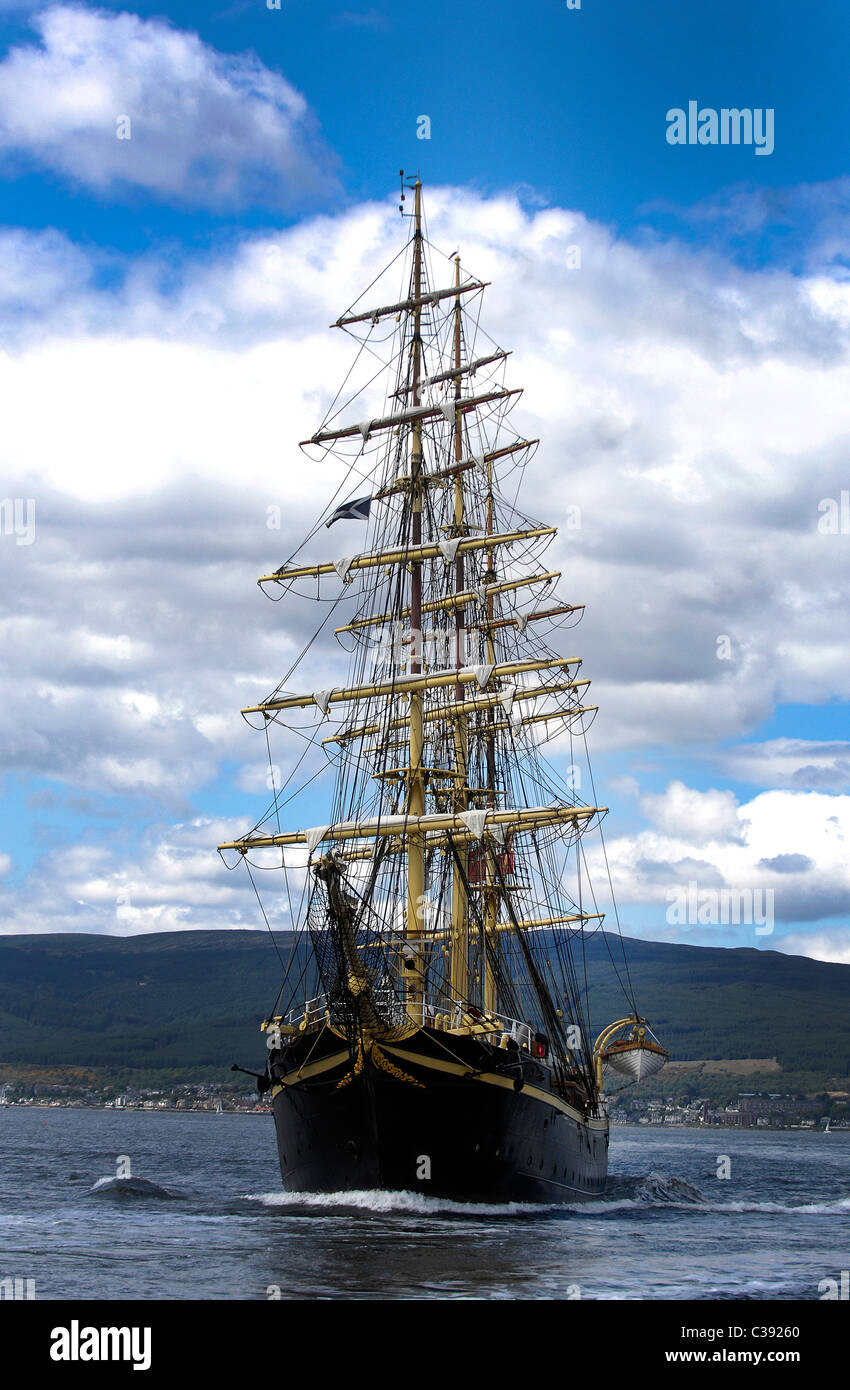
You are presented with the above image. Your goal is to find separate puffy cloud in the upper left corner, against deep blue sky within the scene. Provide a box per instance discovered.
[0,4,333,210]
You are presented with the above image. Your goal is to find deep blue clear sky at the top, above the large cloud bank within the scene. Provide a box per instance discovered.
[6,0,850,253]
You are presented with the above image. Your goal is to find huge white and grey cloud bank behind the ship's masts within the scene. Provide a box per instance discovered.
[0,189,850,950]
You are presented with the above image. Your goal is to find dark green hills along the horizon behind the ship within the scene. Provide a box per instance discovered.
[0,931,850,1079]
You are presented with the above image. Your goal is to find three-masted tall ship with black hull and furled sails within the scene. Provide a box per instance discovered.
[219,174,667,1202]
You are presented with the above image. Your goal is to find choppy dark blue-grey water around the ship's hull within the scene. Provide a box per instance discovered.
[0,1106,850,1300]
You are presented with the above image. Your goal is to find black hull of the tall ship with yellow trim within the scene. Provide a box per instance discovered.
[272,1030,608,1202]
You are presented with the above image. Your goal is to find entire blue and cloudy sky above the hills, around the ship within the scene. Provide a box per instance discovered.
[0,0,850,959]
